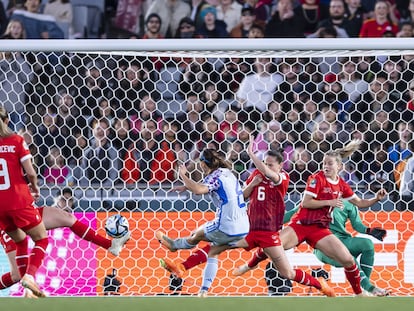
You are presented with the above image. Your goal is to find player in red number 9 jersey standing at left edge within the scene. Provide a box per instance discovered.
[0,107,48,297]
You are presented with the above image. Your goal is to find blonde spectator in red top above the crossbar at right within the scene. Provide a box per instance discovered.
[359,0,398,38]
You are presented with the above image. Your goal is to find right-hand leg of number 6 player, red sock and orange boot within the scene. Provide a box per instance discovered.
[263,245,336,297]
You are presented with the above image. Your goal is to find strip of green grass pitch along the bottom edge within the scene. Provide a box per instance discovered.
[0,297,414,311]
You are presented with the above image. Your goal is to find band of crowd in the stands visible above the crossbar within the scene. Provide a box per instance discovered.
[0,0,414,39]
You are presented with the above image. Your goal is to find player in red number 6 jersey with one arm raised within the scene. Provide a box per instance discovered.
[161,137,335,297]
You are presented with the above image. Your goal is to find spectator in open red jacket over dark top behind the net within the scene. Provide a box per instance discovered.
[121,119,177,184]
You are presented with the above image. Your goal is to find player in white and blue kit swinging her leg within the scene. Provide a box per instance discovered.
[156,149,249,297]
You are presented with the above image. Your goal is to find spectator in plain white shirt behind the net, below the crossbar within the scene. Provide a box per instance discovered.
[237,58,283,114]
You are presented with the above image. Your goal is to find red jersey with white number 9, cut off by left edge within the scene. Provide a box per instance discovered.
[0,134,34,211]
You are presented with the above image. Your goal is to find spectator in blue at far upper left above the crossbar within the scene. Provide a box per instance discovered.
[10,0,64,39]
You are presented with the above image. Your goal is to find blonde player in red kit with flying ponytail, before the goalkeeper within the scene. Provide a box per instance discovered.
[233,140,387,295]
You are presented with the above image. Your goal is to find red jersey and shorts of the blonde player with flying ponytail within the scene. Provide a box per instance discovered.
[292,171,355,228]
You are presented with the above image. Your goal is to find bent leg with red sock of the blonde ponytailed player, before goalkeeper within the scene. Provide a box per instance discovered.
[315,234,362,295]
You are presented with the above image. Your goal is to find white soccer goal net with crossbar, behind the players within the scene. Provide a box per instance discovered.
[0,38,414,296]
